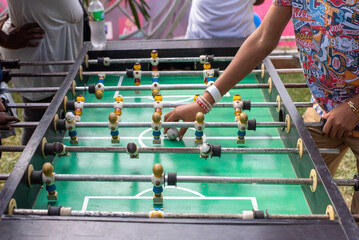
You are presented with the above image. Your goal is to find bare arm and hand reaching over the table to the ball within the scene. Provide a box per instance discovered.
[164,5,291,139]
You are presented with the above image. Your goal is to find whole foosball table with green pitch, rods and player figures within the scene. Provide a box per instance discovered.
[0,39,359,239]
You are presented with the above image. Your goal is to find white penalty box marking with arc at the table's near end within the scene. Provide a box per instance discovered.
[81,186,259,211]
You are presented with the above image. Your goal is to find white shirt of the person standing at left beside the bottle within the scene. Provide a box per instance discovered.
[0,0,83,101]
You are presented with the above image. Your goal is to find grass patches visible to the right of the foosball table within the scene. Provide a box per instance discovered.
[280,74,357,208]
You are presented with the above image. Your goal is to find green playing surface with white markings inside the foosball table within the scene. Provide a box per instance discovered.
[34,73,310,214]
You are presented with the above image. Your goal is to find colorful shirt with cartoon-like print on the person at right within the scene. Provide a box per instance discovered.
[273,0,359,118]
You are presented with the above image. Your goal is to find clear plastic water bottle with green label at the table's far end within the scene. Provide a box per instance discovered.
[88,0,106,49]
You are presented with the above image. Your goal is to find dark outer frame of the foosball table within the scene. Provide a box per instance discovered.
[0,39,359,240]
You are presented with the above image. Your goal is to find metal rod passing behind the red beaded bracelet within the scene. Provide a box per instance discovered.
[8,101,313,109]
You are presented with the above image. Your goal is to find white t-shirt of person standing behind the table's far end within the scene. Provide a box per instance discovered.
[186,0,255,39]
